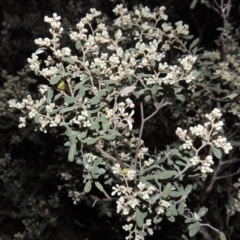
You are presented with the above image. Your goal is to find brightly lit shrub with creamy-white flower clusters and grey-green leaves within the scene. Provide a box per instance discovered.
[3,1,239,240]
